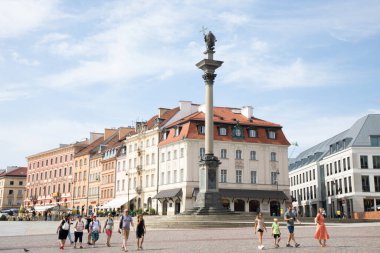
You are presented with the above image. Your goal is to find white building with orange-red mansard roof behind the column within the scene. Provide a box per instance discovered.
[154,102,289,215]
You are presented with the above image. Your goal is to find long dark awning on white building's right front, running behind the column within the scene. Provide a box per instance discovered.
[193,188,288,200]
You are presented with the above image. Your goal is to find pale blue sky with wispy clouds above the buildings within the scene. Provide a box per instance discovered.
[0,0,380,168]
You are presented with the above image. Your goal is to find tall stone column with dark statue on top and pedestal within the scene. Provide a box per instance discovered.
[195,32,224,214]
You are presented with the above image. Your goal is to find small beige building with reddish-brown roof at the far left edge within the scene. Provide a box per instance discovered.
[0,167,27,210]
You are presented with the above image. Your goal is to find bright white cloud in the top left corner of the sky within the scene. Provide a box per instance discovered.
[0,0,58,38]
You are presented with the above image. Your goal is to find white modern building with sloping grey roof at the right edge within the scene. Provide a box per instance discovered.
[289,114,380,217]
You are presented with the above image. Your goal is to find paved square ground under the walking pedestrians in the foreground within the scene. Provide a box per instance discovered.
[0,222,380,253]
